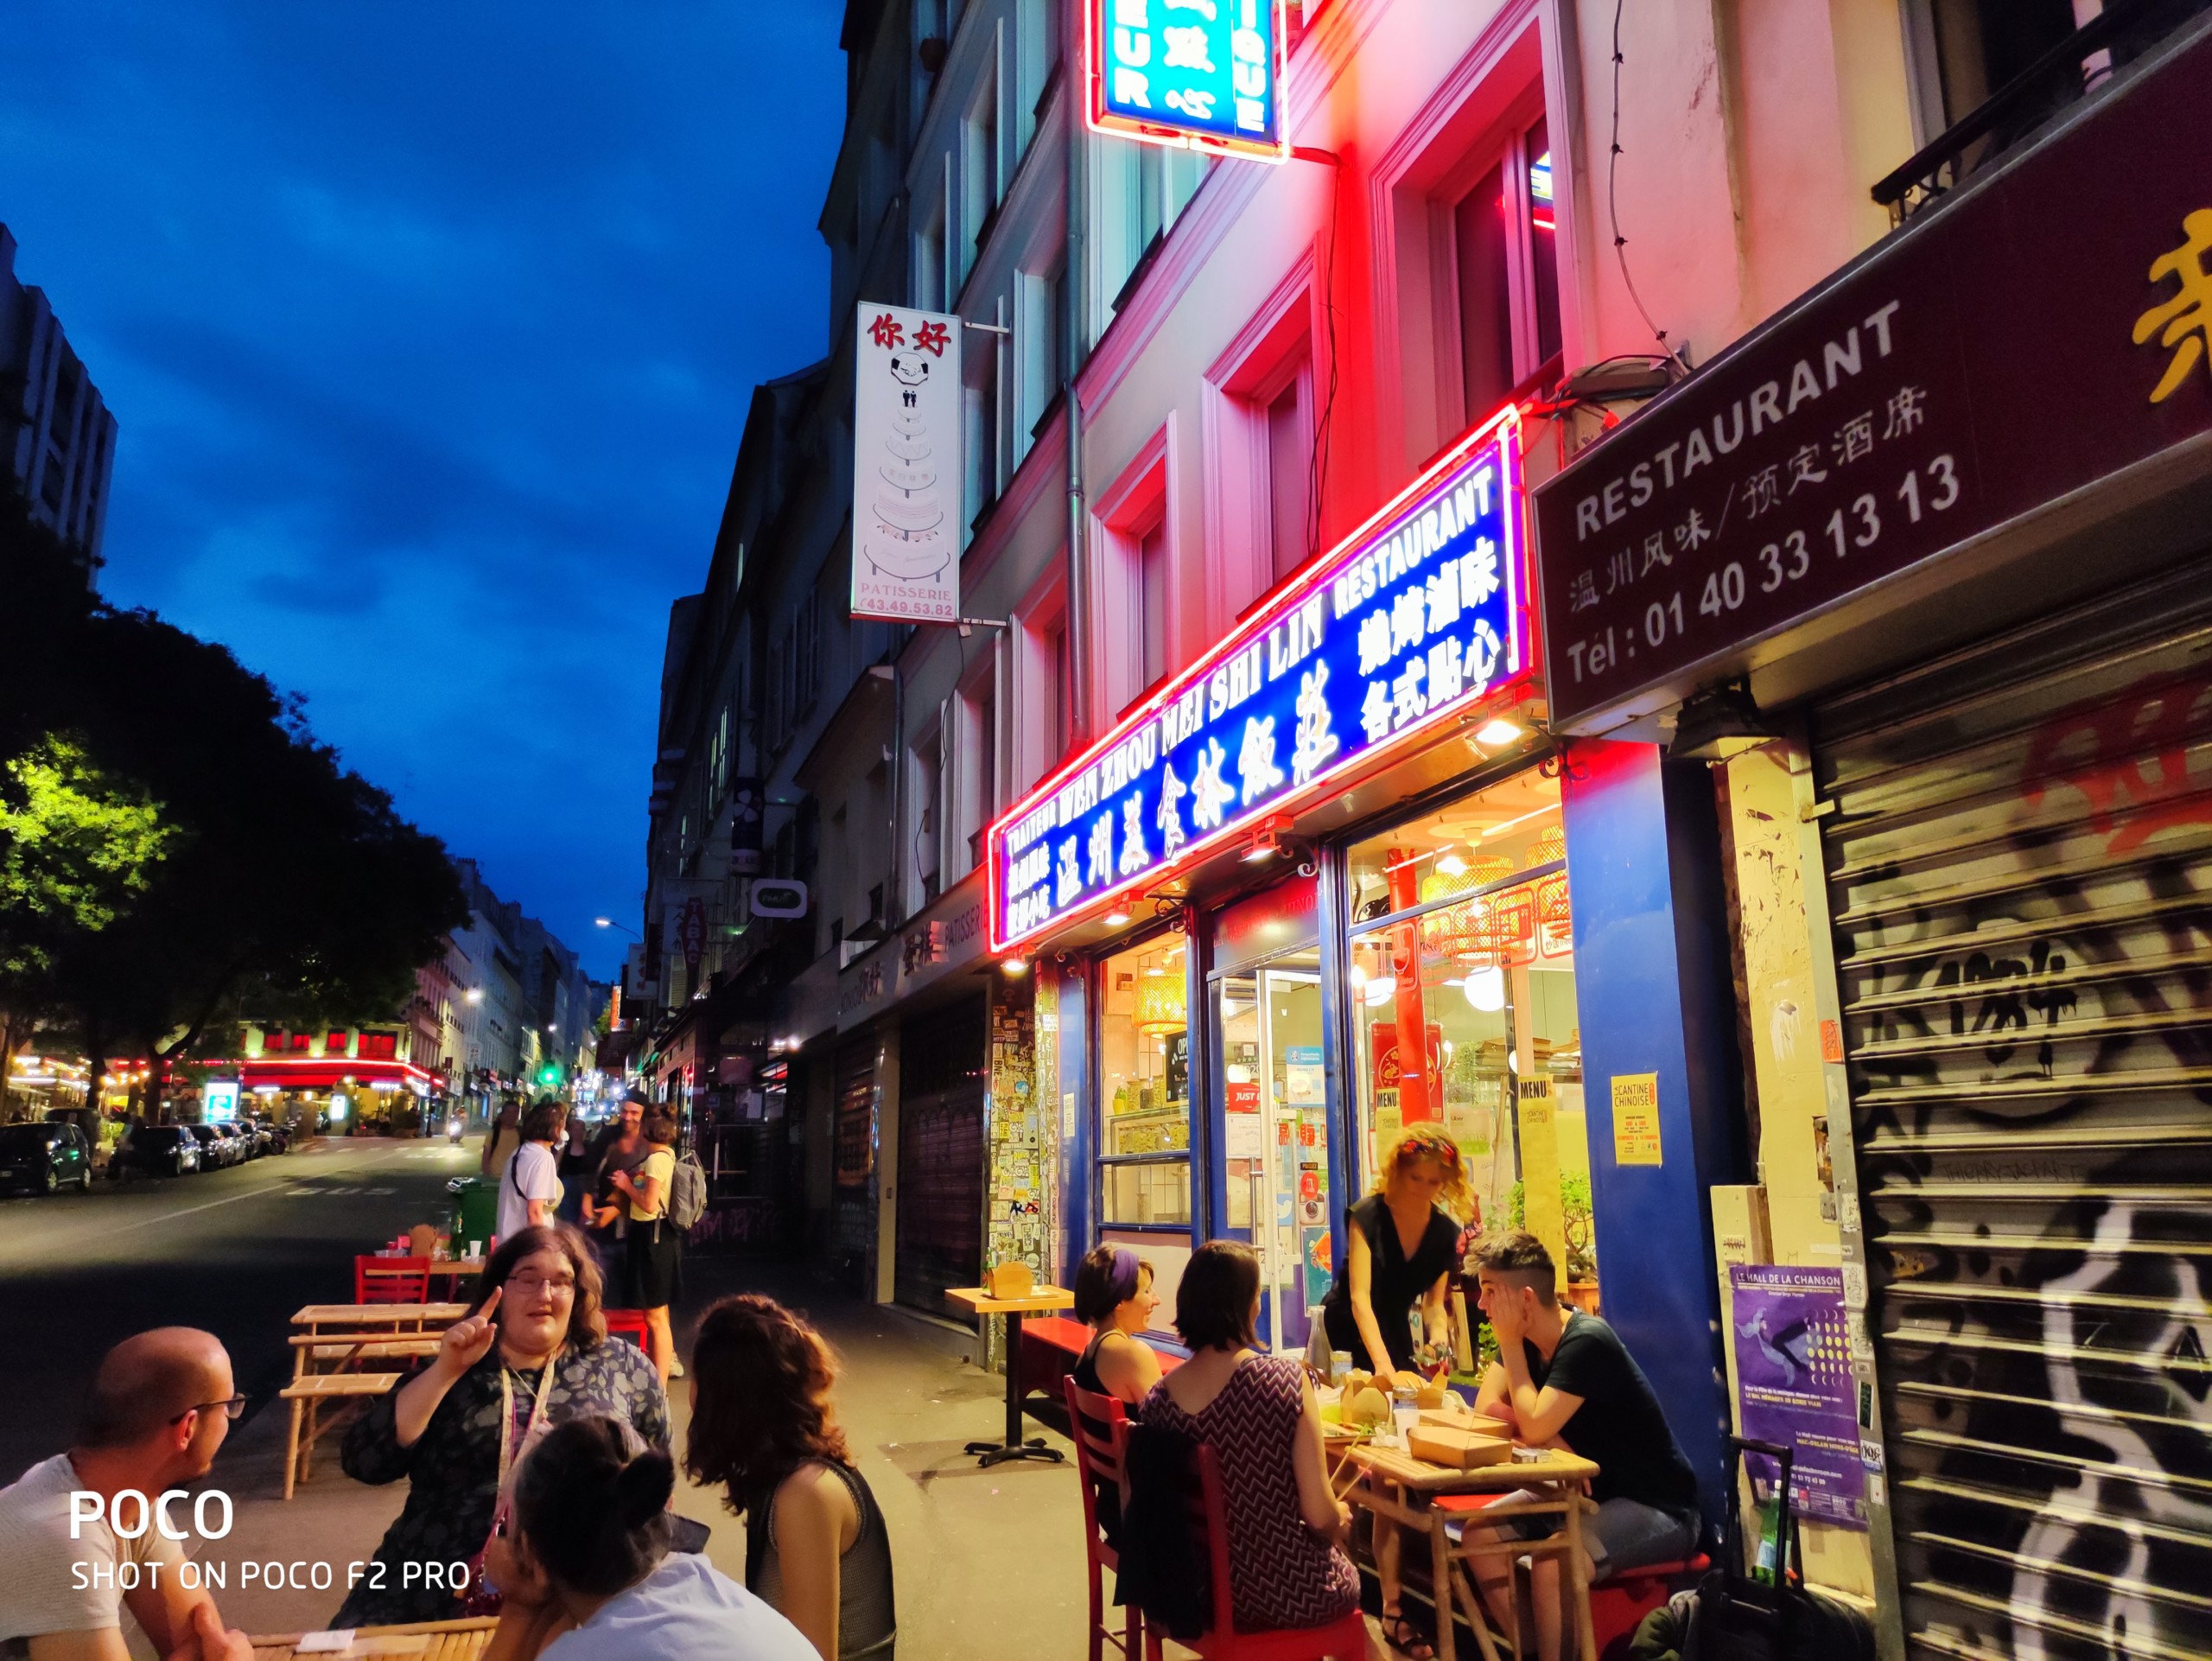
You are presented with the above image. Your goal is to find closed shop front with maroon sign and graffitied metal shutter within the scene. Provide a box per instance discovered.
[1537,24,2212,1657]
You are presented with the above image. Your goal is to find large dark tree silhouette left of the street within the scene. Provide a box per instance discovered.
[0,487,467,1117]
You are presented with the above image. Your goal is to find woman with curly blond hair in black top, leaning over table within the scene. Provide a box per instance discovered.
[1320,1123,1482,1391]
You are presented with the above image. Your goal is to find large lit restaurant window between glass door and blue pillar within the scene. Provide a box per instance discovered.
[1347,772,1597,1309]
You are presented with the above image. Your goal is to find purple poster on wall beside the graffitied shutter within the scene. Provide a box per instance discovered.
[1727,1263,1867,1528]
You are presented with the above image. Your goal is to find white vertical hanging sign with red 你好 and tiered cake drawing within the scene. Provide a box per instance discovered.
[852,303,967,624]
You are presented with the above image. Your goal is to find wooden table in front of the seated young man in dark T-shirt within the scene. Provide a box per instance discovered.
[1343,1442,1597,1661]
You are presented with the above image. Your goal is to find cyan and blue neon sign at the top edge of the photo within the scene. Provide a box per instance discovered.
[1086,0,1289,162]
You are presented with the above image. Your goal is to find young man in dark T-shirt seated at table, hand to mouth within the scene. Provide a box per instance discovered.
[1471,1232,1703,1661]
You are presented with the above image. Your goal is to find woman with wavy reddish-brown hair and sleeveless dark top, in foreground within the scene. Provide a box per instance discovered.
[683,1292,898,1661]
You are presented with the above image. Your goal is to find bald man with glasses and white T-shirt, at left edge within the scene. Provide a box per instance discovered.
[0,1327,252,1661]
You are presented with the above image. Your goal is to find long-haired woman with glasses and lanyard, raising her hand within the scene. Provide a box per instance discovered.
[332,1225,668,1628]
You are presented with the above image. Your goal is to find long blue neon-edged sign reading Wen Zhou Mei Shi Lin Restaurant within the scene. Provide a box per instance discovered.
[987,407,1529,951]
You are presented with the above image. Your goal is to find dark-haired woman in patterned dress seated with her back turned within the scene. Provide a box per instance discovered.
[1144,1241,1360,1630]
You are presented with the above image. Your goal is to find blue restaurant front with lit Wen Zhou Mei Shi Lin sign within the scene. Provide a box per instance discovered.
[988,409,1737,1488]
